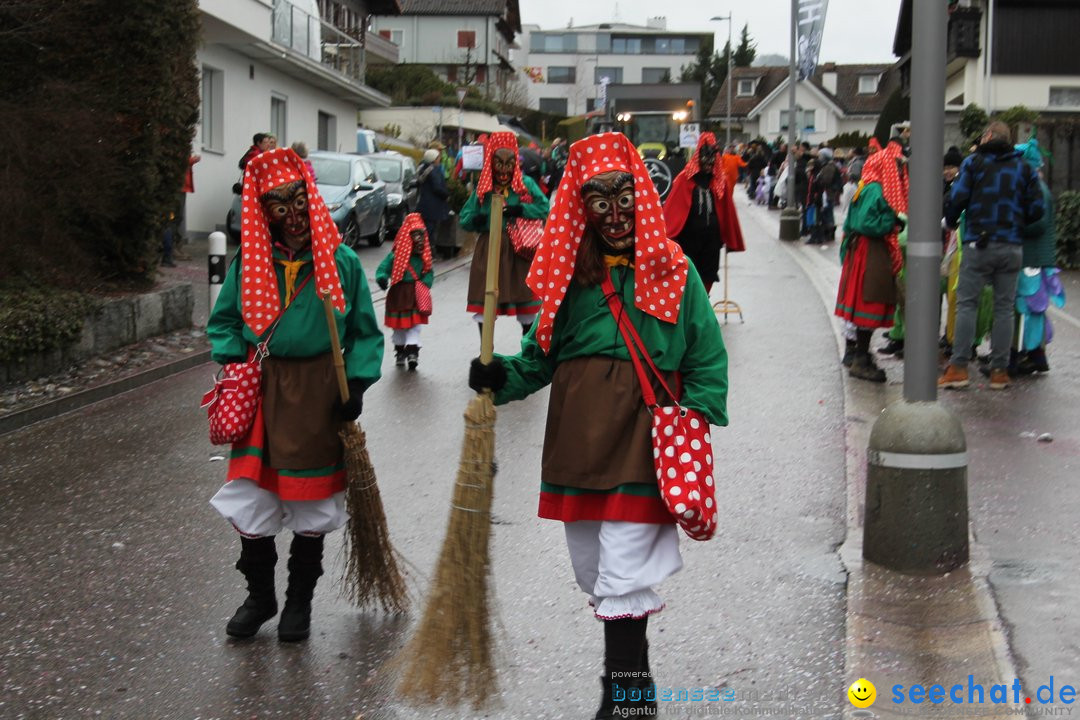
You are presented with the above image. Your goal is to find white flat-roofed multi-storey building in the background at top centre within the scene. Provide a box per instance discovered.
[513,17,713,116]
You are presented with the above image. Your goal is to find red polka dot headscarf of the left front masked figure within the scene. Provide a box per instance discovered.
[240,148,345,336]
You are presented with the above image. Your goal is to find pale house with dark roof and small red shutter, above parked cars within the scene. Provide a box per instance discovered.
[372,0,522,98]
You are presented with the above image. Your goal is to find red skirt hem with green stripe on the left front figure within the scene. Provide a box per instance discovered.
[226,403,346,501]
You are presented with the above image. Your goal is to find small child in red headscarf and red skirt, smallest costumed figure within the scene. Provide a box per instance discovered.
[375,213,435,370]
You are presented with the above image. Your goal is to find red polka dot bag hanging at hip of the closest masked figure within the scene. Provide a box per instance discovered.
[652,406,717,540]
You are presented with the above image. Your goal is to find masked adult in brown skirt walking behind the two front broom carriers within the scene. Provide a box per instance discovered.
[460,133,548,334]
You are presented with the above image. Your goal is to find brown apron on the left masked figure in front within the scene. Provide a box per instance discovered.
[262,353,342,470]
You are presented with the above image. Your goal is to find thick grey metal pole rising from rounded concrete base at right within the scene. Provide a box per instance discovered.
[904,0,947,403]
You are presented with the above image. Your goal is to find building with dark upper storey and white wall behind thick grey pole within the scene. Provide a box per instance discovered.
[893,0,1080,191]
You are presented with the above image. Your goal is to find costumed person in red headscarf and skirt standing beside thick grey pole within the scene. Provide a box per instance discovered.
[835,140,908,382]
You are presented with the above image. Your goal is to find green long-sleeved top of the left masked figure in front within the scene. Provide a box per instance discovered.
[206,244,383,389]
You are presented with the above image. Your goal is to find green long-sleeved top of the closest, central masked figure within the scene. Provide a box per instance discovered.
[496,266,728,425]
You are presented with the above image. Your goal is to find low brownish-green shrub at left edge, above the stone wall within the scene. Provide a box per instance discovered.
[0,283,97,363]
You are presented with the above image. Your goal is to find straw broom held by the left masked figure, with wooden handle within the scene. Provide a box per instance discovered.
[323,293,408,612]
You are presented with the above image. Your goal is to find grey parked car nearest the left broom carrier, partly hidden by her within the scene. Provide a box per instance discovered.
[308,151,388,247]
